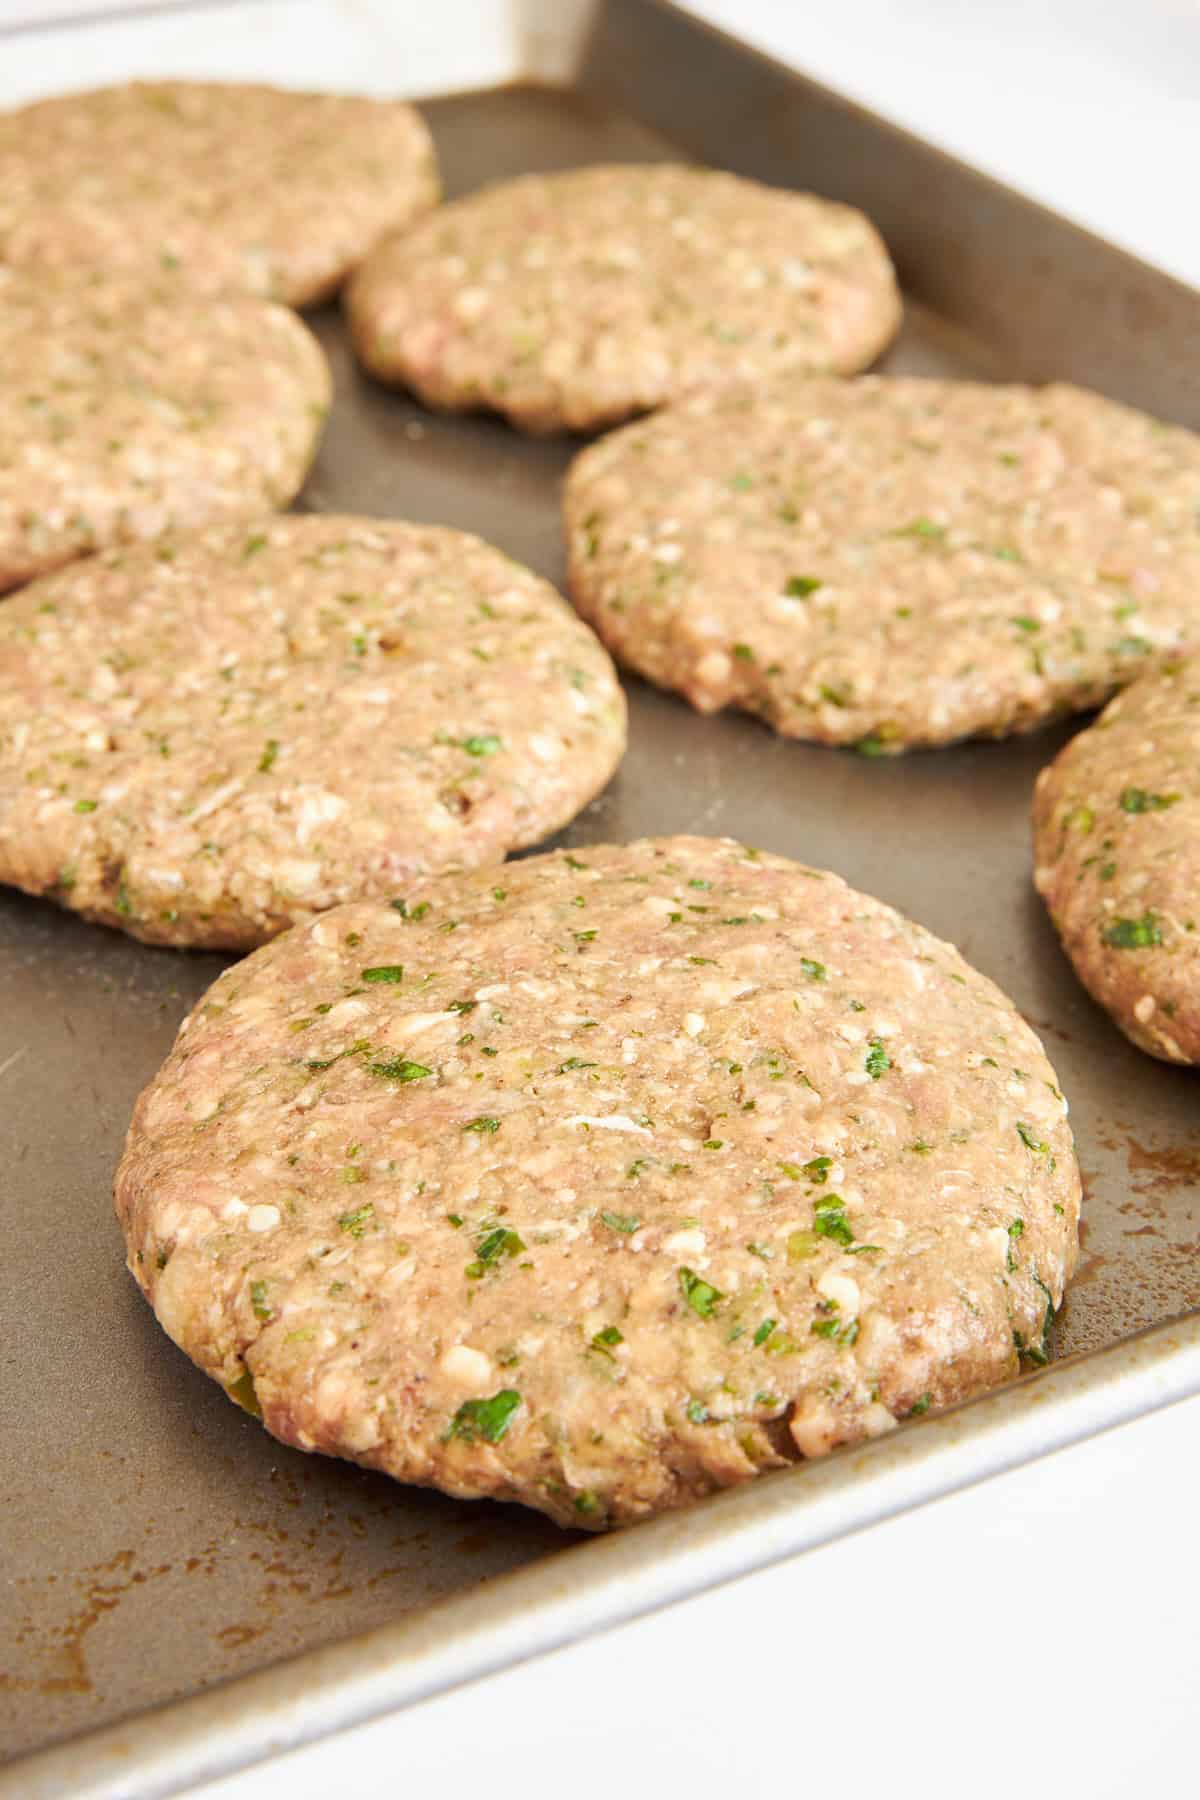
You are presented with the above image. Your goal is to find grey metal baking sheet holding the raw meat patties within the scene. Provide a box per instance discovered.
[0,0,1200,1796]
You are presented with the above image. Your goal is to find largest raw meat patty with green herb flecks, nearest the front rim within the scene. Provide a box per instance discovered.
[117,837,1079,1528]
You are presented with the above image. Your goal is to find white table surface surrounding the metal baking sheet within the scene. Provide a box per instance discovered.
[0,0,1200,1800]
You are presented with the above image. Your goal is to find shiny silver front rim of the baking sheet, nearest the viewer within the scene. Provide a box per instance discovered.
[9,1309,1200,1800]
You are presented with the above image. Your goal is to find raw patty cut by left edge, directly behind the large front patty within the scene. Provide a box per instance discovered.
[0,515,624,949]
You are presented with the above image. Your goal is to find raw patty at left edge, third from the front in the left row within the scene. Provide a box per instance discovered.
[0,270,331,592]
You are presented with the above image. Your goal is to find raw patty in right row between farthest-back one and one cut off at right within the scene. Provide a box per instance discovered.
[567,376,1200,754]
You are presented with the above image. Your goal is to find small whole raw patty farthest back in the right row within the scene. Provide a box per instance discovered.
[341,164,900,432]
